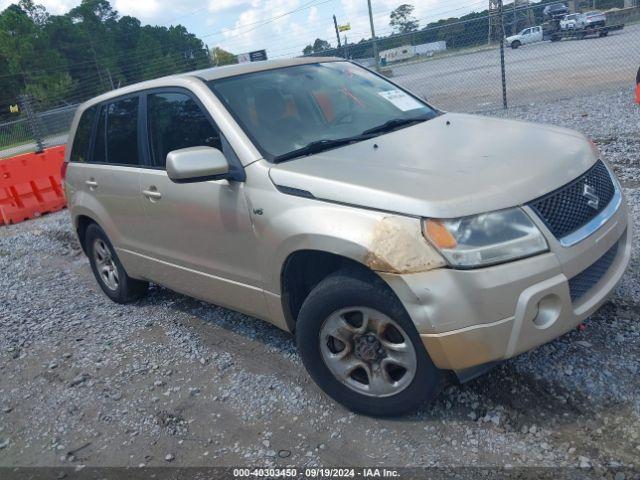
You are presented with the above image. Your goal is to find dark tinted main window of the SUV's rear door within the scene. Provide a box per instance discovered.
[107,97,139,165]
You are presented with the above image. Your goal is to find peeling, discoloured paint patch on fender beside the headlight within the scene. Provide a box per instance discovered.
[365,217,445,273]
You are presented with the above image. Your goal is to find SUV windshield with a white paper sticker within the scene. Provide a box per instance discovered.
[209,62,436,161]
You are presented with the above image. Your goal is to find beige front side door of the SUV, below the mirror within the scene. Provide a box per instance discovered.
[134,90,265,314]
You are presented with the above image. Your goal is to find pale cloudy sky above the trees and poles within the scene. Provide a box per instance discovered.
[0,0,489,58]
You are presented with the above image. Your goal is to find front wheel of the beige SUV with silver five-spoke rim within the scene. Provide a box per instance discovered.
[296,269,443,416]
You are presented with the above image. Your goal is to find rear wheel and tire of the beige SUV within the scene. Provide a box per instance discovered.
[85,223,149,303]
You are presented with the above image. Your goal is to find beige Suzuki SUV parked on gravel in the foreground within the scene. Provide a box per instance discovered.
[62,58,632,415]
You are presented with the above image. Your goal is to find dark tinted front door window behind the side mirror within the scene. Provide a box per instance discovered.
[147,93,222,167]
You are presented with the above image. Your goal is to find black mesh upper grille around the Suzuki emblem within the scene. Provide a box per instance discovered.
[529,160,615,238]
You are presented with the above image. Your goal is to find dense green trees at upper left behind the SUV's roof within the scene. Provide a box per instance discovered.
[0,0,211,113]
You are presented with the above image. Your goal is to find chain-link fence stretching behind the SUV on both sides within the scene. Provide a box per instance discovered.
[0,0,640,157]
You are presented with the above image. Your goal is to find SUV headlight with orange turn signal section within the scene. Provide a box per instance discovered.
[422,208,549,268]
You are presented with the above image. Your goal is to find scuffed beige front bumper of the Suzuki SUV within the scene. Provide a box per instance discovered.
[382,201,632,370]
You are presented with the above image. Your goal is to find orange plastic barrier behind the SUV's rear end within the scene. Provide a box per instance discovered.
[0,146,67,225]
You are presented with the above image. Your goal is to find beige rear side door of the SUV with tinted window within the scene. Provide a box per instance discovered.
[69,95,144,258]
